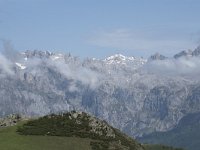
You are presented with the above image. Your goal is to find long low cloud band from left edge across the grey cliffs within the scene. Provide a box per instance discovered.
[0,40,100,91]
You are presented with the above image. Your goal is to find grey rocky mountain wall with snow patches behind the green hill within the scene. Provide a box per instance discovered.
[0,48,200,136]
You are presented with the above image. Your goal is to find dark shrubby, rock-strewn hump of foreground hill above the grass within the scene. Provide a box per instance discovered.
[17,111,144,150]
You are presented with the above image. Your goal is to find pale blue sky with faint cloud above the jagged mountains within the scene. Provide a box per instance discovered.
[0,0,200,58]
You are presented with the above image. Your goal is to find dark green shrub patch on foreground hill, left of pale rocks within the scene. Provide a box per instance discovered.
[17,113,106,139]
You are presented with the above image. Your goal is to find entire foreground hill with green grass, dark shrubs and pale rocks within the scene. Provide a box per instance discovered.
[0,112,184,150]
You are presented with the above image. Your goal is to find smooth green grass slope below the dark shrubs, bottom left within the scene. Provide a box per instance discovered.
[0,122,91,150]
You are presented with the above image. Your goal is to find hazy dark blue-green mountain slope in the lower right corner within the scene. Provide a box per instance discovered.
[139,113,200,150]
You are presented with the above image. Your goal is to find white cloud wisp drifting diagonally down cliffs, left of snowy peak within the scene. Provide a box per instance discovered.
[25,58,101,91]
